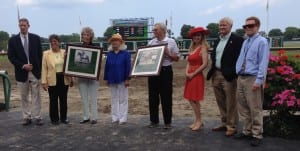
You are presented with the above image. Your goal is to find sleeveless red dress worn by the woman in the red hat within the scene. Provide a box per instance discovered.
[184,47,204,101]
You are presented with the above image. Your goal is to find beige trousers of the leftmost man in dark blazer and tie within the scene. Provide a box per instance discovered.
[17,72,42,119]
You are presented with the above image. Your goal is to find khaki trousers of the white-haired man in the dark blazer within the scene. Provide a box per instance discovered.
[212,70,238,130]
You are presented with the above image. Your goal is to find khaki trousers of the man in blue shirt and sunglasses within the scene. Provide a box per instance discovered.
[237,76,263,139]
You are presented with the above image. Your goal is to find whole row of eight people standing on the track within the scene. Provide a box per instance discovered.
[8,17,270,146]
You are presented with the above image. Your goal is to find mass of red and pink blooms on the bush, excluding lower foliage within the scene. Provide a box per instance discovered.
[264,50,300,111]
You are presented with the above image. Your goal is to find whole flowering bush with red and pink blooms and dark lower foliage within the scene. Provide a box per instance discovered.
[264,50,300,137]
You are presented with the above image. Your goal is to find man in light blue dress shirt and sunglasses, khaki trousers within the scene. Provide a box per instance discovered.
[235,17,270,146]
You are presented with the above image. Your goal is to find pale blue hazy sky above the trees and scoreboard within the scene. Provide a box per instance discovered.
[0,0,300,37]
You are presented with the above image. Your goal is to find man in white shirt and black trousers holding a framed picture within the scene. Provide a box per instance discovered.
[148,23,179,129]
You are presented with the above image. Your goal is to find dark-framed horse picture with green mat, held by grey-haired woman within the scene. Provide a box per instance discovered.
[63,44,103,80]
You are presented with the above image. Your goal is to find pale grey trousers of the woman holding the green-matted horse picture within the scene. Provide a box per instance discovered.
[78,78,99,120]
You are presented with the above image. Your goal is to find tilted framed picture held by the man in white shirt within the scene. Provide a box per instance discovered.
[131,44,166,76]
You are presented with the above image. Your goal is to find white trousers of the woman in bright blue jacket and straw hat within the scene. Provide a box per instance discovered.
[109,83,128,122]
